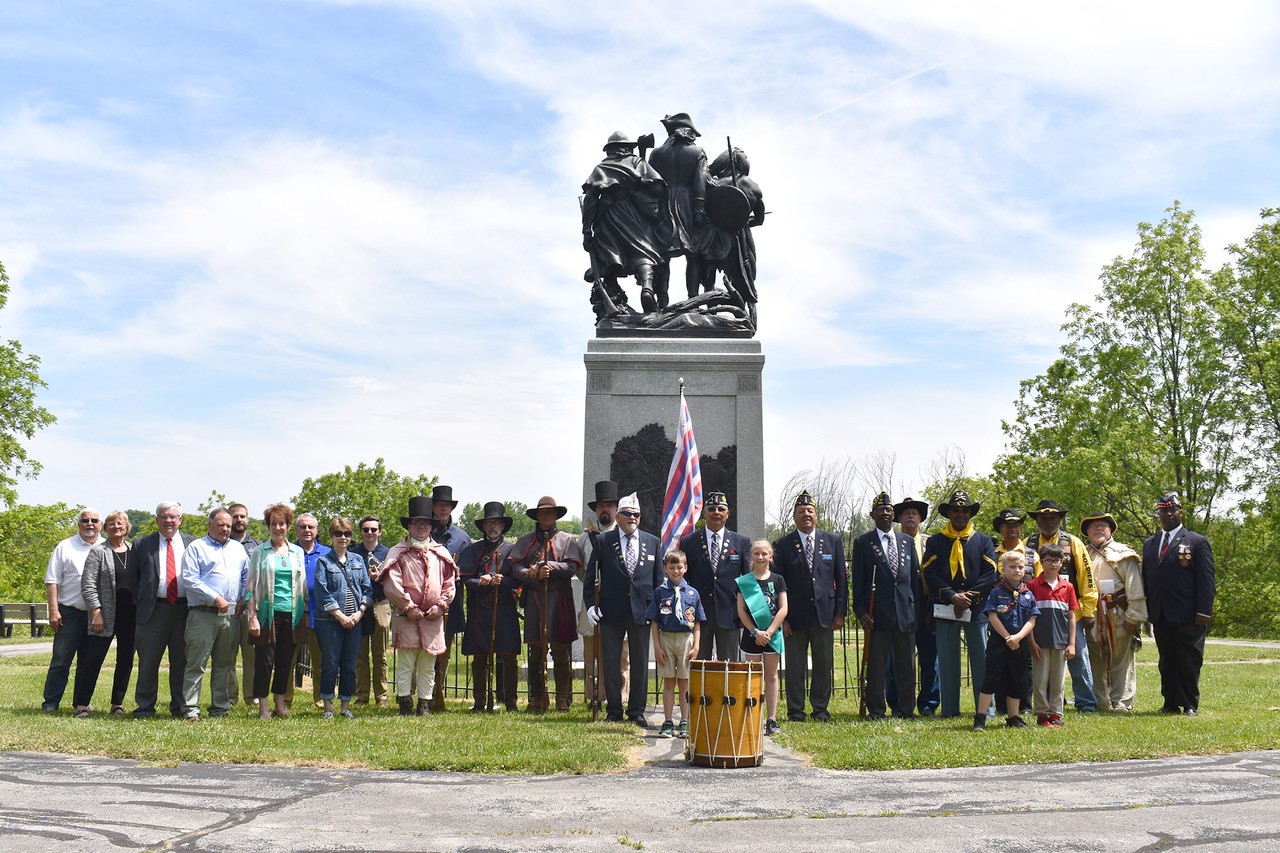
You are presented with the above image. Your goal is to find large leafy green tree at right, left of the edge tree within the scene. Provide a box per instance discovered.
[993,201,1239,538]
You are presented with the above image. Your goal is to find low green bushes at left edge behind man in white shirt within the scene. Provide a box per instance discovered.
[0,503,79,602]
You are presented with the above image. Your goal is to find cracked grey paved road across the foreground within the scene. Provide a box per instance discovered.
[0,740,1280,853]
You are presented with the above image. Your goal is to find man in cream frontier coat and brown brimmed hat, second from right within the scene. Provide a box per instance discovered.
[1080,512,1147,713]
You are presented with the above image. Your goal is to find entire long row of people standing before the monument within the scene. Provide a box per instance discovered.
[42,480,1215,736]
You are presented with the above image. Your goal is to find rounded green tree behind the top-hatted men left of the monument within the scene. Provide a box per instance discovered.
[292,457,437,543]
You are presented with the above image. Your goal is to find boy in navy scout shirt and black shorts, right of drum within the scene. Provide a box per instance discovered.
[973,551,1039,731]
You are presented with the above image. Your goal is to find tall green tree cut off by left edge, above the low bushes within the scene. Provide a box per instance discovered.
[0,256,55,503]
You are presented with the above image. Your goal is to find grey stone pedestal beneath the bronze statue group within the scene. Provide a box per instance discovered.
[582,337,764,539]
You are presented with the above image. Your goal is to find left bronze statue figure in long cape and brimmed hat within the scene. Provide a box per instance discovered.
[582,131,666,319]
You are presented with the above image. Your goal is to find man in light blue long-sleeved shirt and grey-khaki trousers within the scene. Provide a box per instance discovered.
[182,508,248,722]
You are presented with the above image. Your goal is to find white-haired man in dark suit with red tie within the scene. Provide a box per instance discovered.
[127,501,195,719]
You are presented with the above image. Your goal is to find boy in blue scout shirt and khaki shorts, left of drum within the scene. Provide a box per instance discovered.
[645,549,707,738]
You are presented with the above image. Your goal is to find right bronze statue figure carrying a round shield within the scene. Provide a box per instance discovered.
[703,147,764,327]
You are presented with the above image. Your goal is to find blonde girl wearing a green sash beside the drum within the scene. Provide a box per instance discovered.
[737,539,787,735]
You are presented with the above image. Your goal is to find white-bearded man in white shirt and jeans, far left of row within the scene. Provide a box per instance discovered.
[40,507,102,713]
